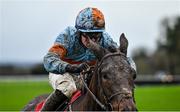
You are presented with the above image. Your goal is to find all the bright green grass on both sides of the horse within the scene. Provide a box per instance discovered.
[0,81,180,111]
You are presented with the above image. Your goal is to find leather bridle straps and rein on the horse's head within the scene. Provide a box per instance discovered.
[80,52,132,111]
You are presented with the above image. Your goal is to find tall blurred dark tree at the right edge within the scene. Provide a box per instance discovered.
[156,17,180,74]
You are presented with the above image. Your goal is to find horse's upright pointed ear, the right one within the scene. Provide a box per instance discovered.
[119,33,128,55]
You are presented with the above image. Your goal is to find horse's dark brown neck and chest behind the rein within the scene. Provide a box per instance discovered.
[73,74,99,111]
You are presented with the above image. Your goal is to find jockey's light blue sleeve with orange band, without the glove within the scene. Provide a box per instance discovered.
[44,28,73,74]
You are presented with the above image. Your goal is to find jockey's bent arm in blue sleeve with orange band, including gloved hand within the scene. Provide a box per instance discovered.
[44,27,89,74]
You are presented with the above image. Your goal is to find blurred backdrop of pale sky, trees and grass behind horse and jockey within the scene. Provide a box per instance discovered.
[0,0,180,111]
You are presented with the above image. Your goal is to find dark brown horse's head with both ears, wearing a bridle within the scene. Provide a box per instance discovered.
[87,34,136,111]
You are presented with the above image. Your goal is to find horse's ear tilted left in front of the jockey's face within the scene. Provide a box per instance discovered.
[88,40,107,60]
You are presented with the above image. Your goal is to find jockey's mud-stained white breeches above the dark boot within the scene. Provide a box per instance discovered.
[49,73,77,98]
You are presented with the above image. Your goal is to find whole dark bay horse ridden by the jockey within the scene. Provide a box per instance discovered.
[24,34,137,111]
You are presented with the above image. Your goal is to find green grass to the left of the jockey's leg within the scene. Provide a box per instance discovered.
[0,81,51,111]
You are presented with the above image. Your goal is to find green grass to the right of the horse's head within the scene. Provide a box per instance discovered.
[135,85,180,111]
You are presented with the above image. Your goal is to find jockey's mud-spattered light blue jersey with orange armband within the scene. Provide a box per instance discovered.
[44,27,118,74]
